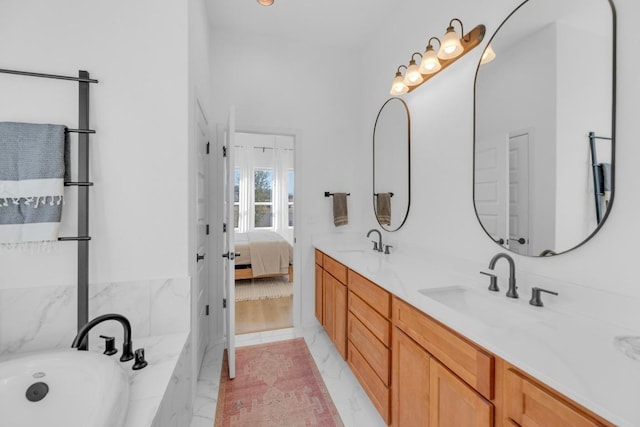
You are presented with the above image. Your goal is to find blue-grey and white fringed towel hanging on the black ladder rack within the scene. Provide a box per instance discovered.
[0,122,68,250]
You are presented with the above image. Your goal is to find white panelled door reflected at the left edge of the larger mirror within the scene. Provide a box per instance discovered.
[474,135,508,244]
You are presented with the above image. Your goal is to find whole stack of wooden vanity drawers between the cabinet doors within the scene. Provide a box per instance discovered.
[347,270,391,424]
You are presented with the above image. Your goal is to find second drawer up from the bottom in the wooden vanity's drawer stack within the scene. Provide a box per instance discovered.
[348,313,389,386]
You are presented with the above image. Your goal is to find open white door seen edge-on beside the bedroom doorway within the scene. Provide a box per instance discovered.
[222,107,236,378]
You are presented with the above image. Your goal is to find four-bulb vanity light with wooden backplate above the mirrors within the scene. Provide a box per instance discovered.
[390,18,484,96]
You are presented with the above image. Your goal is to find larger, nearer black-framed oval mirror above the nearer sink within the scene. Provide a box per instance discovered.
[474,0,616,256]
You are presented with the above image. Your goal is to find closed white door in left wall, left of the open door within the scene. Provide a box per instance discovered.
[191,104,209,378]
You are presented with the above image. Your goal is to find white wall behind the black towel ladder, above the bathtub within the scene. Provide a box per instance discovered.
[0,0,188,288]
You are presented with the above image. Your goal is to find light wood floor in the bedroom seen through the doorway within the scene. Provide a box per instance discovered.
[236,296,293,335]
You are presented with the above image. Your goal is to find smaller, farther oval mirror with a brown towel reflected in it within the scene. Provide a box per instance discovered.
[373,98,411,231]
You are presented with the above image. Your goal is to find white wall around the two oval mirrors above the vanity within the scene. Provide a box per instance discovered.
[360,0,640,296]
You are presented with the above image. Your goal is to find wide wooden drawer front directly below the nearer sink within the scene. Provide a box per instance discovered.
[393,298,495,399]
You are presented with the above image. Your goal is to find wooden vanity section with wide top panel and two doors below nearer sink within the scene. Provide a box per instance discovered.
[391,298,495,427]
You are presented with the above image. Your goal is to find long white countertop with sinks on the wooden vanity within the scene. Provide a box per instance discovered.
[313,235,640,427]
